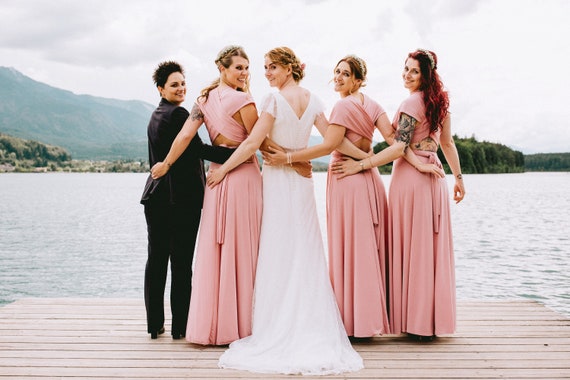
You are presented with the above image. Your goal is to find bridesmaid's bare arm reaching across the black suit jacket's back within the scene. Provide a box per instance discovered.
[151,103,204,179]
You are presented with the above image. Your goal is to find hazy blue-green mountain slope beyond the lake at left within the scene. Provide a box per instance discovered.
[0,67,155,160]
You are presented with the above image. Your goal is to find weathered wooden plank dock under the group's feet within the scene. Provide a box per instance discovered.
[0,298,570,380]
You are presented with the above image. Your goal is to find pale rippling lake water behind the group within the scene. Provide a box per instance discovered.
[0,173,570,316]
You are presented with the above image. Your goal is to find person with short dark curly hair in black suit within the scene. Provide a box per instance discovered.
[141,61,234,339]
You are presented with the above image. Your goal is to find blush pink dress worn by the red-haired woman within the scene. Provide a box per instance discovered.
[389,92,456,336]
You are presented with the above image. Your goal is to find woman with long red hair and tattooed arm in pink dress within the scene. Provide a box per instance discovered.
[334,49,465,341]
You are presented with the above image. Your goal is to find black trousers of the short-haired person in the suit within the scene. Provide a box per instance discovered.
[144,203,202,335]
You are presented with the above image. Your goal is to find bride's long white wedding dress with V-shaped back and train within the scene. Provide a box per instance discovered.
[215,93,363,375]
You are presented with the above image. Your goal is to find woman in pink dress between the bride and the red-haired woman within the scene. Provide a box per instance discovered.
[264,55,392,338]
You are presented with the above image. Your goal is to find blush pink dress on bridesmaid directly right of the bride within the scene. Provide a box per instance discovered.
[327,96,390,337]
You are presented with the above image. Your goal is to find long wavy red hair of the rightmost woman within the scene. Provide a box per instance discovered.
[408,49,449,132]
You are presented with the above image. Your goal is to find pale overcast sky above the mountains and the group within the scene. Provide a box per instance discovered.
[0,0,570,154]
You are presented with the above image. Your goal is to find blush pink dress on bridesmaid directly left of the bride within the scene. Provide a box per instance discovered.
[186,86,262,345]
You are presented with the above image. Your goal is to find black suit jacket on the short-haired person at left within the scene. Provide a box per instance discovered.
[141,99,235,207]
